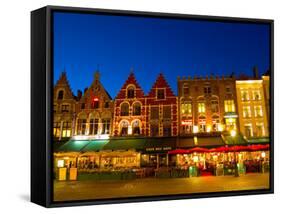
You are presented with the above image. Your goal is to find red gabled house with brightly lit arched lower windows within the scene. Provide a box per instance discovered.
[113,72,146,136]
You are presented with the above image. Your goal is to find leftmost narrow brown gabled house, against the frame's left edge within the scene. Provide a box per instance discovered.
[53,72,76,141]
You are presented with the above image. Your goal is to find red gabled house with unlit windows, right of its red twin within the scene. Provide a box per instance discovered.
[146,73,178,137]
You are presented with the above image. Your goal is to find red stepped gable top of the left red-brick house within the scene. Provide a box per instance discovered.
[116,72,144,99]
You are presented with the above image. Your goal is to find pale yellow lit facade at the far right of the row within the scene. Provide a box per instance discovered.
[236,79,269,139]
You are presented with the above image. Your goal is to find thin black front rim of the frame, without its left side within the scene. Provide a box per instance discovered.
[31,6,274,207]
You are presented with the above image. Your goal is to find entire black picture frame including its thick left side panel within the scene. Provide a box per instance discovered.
[31,6,274,207]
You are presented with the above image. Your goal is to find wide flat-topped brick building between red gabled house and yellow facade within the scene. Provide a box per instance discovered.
[178,76,238,135]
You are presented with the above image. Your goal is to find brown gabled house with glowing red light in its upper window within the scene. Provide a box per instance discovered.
[75,71,113,139]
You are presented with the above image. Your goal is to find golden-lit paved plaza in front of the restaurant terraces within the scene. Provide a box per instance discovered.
[54,173,269,201]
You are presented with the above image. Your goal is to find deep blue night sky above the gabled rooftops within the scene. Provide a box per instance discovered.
[54,12,270,98]
